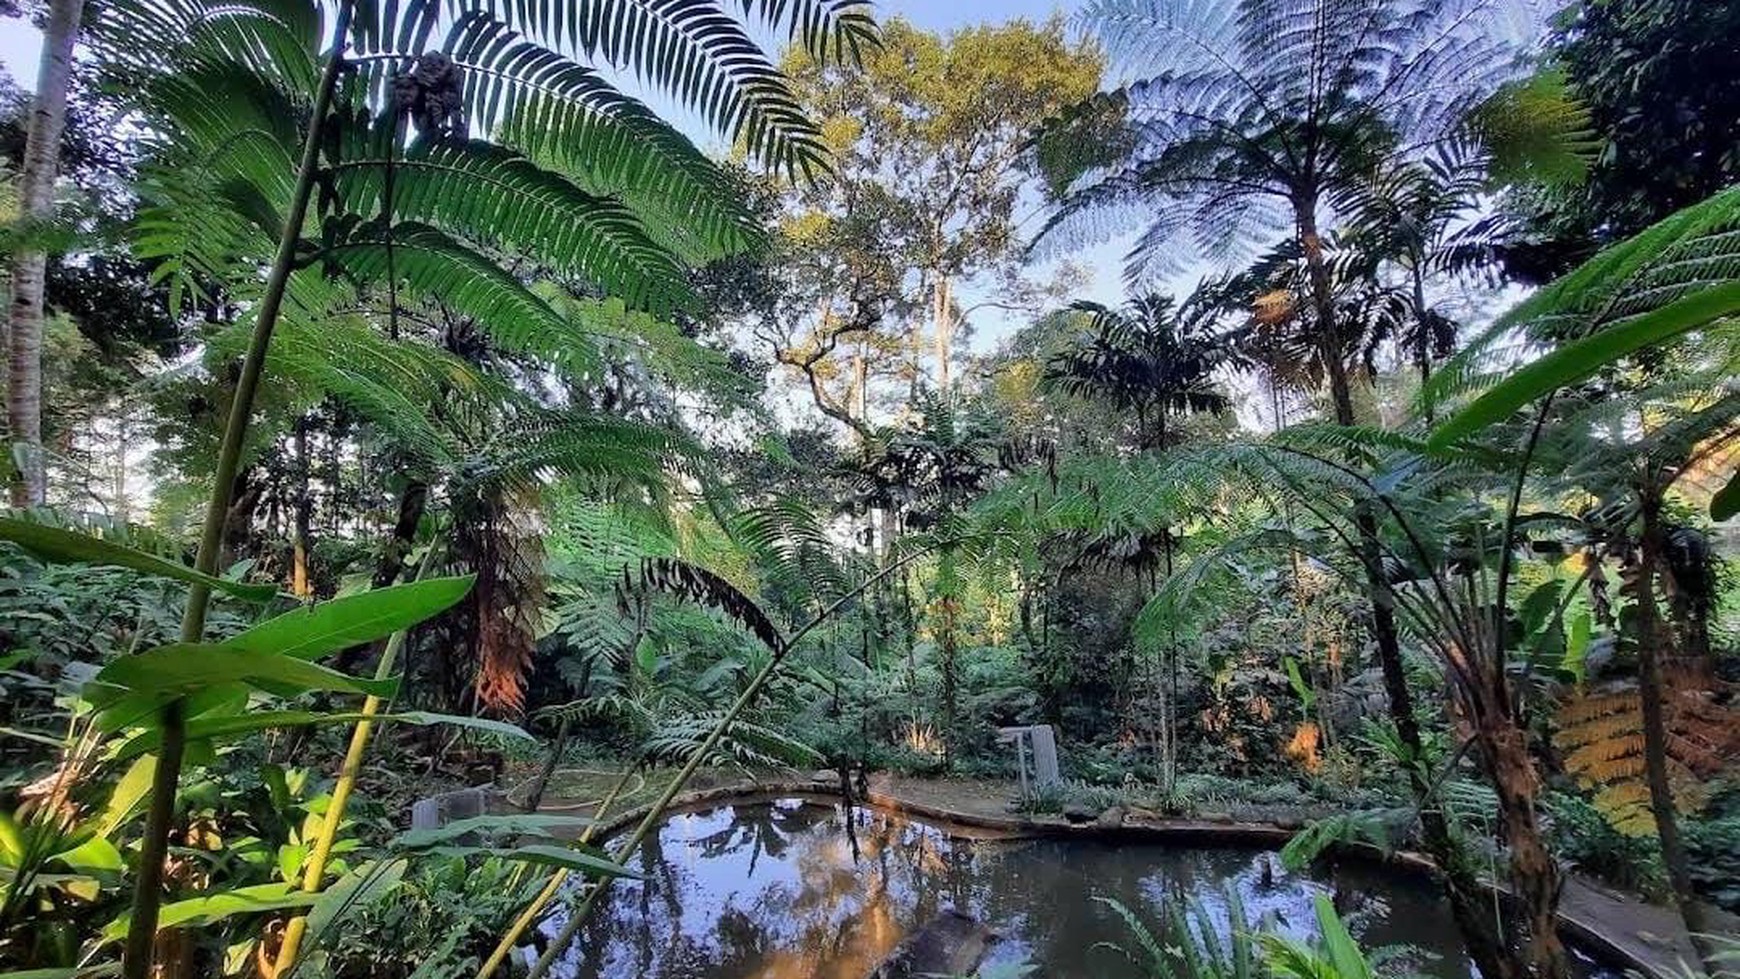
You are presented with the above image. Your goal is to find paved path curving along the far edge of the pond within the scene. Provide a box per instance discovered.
[543,774,1697,979]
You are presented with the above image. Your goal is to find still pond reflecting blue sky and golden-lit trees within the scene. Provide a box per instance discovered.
[545,800,1611,979]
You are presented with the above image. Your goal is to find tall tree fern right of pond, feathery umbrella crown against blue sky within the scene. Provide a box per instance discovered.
[1041,0,1538,979]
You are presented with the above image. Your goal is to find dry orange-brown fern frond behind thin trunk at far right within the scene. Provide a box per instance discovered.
[1554,671,1740,836]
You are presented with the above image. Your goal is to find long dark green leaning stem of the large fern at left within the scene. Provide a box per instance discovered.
[122,3,351,979]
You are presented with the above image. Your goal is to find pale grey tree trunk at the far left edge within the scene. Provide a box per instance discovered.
[7,0,85,506]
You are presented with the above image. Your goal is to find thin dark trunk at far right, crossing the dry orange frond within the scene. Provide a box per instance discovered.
[1634,487,1719,976]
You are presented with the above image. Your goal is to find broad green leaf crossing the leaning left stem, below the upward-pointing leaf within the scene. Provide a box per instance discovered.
[97,643,398,697]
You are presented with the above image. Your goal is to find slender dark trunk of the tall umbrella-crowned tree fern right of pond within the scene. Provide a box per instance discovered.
[1295,198,1524,979]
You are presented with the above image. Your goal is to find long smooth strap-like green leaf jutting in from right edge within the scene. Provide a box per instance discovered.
[1427,282,1740,450]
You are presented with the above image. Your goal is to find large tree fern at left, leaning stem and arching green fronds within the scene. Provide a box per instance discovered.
[94,0,872,979]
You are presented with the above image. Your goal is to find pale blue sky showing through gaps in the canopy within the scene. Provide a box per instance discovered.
[0,0,1124,353]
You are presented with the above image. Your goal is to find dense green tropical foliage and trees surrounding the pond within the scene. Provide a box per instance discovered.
[0,0,1740,979]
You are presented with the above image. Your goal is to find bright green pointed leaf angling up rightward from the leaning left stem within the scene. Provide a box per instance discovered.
[219,576,475,659]
